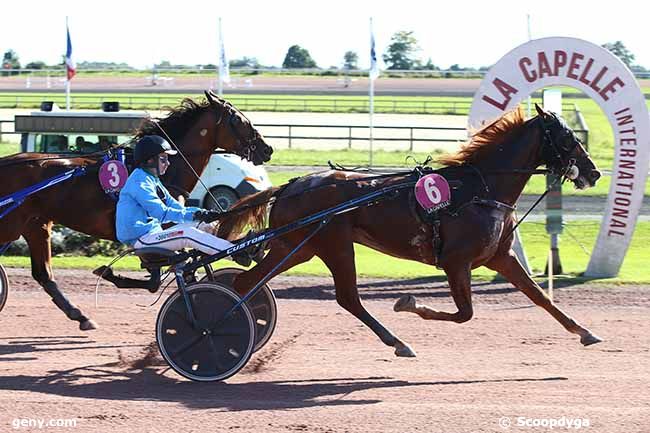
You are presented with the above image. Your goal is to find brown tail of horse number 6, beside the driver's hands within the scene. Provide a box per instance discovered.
[217,187,282,240]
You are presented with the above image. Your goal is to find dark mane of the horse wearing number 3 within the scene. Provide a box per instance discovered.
[134,98,210,140]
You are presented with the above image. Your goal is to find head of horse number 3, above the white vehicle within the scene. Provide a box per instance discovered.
[205,91,273,165]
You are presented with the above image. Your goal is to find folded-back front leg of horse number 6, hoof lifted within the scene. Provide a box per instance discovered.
[393,264,474,323]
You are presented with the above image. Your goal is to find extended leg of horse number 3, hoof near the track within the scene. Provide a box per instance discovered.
[23,219,97,331]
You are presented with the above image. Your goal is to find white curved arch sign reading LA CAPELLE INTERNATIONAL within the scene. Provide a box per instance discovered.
[468,37,650,278]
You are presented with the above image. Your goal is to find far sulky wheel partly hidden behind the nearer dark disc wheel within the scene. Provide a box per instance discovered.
[201,268,278,352]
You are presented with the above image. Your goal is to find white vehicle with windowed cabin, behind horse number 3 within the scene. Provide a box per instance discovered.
[15,110,271,209]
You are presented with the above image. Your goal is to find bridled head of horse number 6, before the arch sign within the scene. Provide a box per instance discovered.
[535,104,601,189]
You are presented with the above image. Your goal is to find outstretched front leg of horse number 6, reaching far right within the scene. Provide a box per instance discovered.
[487,252,602,346]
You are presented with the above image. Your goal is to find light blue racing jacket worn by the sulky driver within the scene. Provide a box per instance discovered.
[115,168,199,245]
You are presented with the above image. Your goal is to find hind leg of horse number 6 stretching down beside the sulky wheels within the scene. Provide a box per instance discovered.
[317,231,416,358]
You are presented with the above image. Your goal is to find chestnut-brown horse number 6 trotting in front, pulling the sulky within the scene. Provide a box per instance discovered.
[219,107,600,356]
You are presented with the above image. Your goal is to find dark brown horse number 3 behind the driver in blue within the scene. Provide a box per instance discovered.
[0,92,273,330]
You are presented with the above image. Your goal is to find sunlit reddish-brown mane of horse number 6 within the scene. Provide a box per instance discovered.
[437,107,525,167]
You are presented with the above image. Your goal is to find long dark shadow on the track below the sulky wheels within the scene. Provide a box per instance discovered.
[0,362,568,411]
